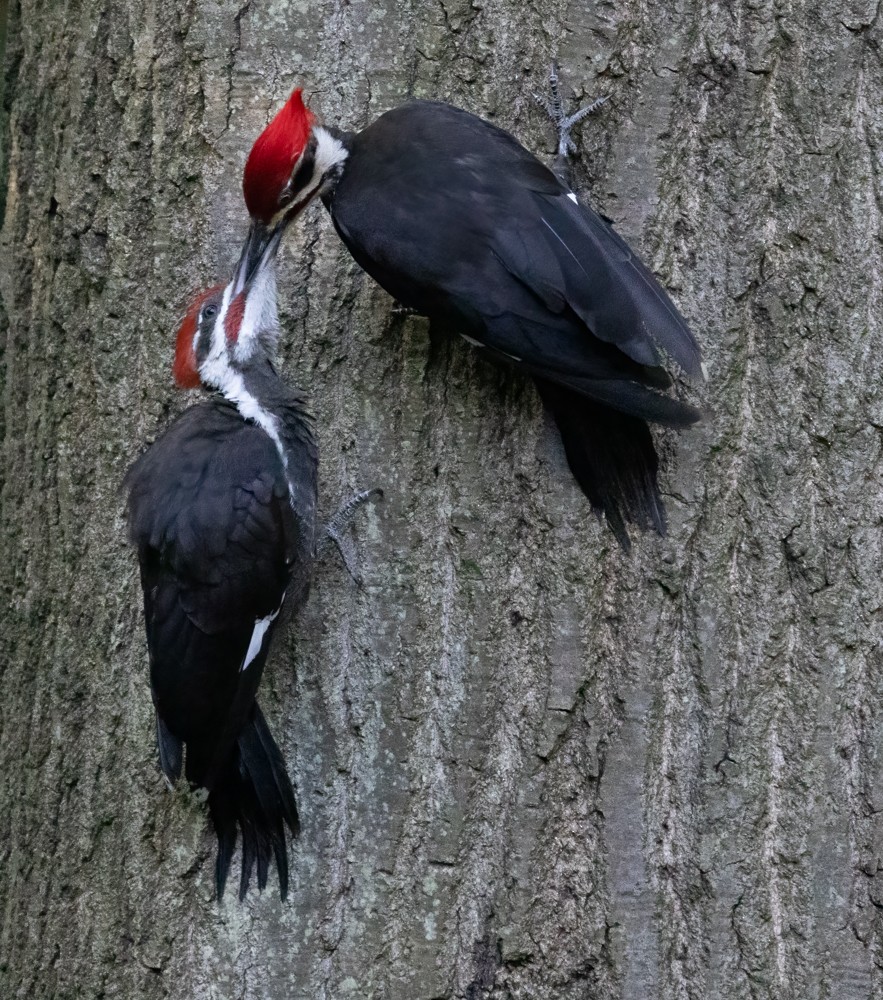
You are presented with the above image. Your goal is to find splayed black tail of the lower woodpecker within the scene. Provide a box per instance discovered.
[208,704,300,900]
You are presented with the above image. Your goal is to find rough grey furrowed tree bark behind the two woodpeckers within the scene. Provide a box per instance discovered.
[0,0,883,1000]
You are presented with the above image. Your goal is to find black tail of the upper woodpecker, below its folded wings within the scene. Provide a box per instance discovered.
[537,380,666,551]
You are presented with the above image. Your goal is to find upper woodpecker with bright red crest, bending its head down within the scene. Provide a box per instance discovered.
[233,74,701,547]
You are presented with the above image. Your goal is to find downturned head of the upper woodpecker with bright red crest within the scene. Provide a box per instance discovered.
[234,87,347,290]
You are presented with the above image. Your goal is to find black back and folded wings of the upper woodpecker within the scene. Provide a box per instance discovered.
[330,101,701,424]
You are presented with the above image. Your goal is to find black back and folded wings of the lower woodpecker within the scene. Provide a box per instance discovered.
[126,403,298,784]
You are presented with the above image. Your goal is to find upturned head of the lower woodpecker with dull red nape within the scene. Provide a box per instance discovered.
[172,230,282,394]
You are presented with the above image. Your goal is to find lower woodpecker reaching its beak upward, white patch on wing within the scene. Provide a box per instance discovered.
[126,232,317,899]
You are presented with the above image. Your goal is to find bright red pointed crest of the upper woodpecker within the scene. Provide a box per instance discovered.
[242,87,315,223]
